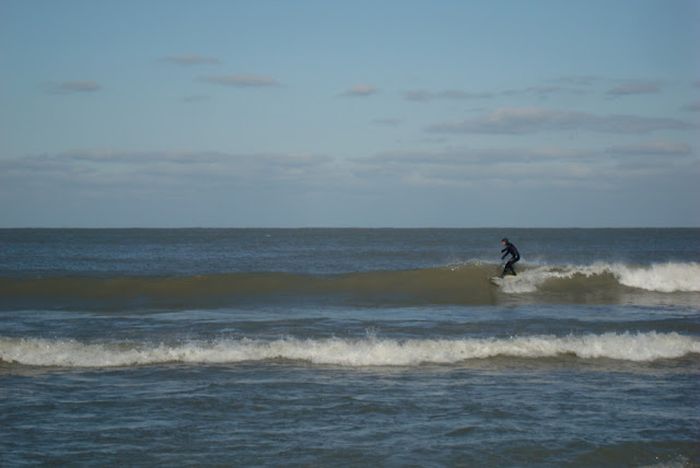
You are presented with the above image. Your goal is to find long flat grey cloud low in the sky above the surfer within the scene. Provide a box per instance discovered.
[354,142,698,189]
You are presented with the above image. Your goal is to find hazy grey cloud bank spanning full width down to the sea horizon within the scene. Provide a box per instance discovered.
[0,146,700,226]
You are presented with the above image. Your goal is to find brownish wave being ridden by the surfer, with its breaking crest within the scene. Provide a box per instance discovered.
[0,263,700,309]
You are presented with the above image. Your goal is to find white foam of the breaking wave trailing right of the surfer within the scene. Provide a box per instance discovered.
[495,262,700,294]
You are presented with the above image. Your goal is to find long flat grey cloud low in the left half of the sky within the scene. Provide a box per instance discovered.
[0,150,333,189]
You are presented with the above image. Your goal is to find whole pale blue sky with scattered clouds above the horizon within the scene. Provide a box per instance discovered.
[0,0,700,227]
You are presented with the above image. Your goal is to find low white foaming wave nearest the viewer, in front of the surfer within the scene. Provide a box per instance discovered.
[0,332,700,368]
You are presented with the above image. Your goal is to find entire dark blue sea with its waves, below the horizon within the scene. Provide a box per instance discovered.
[0,229,700,466]
